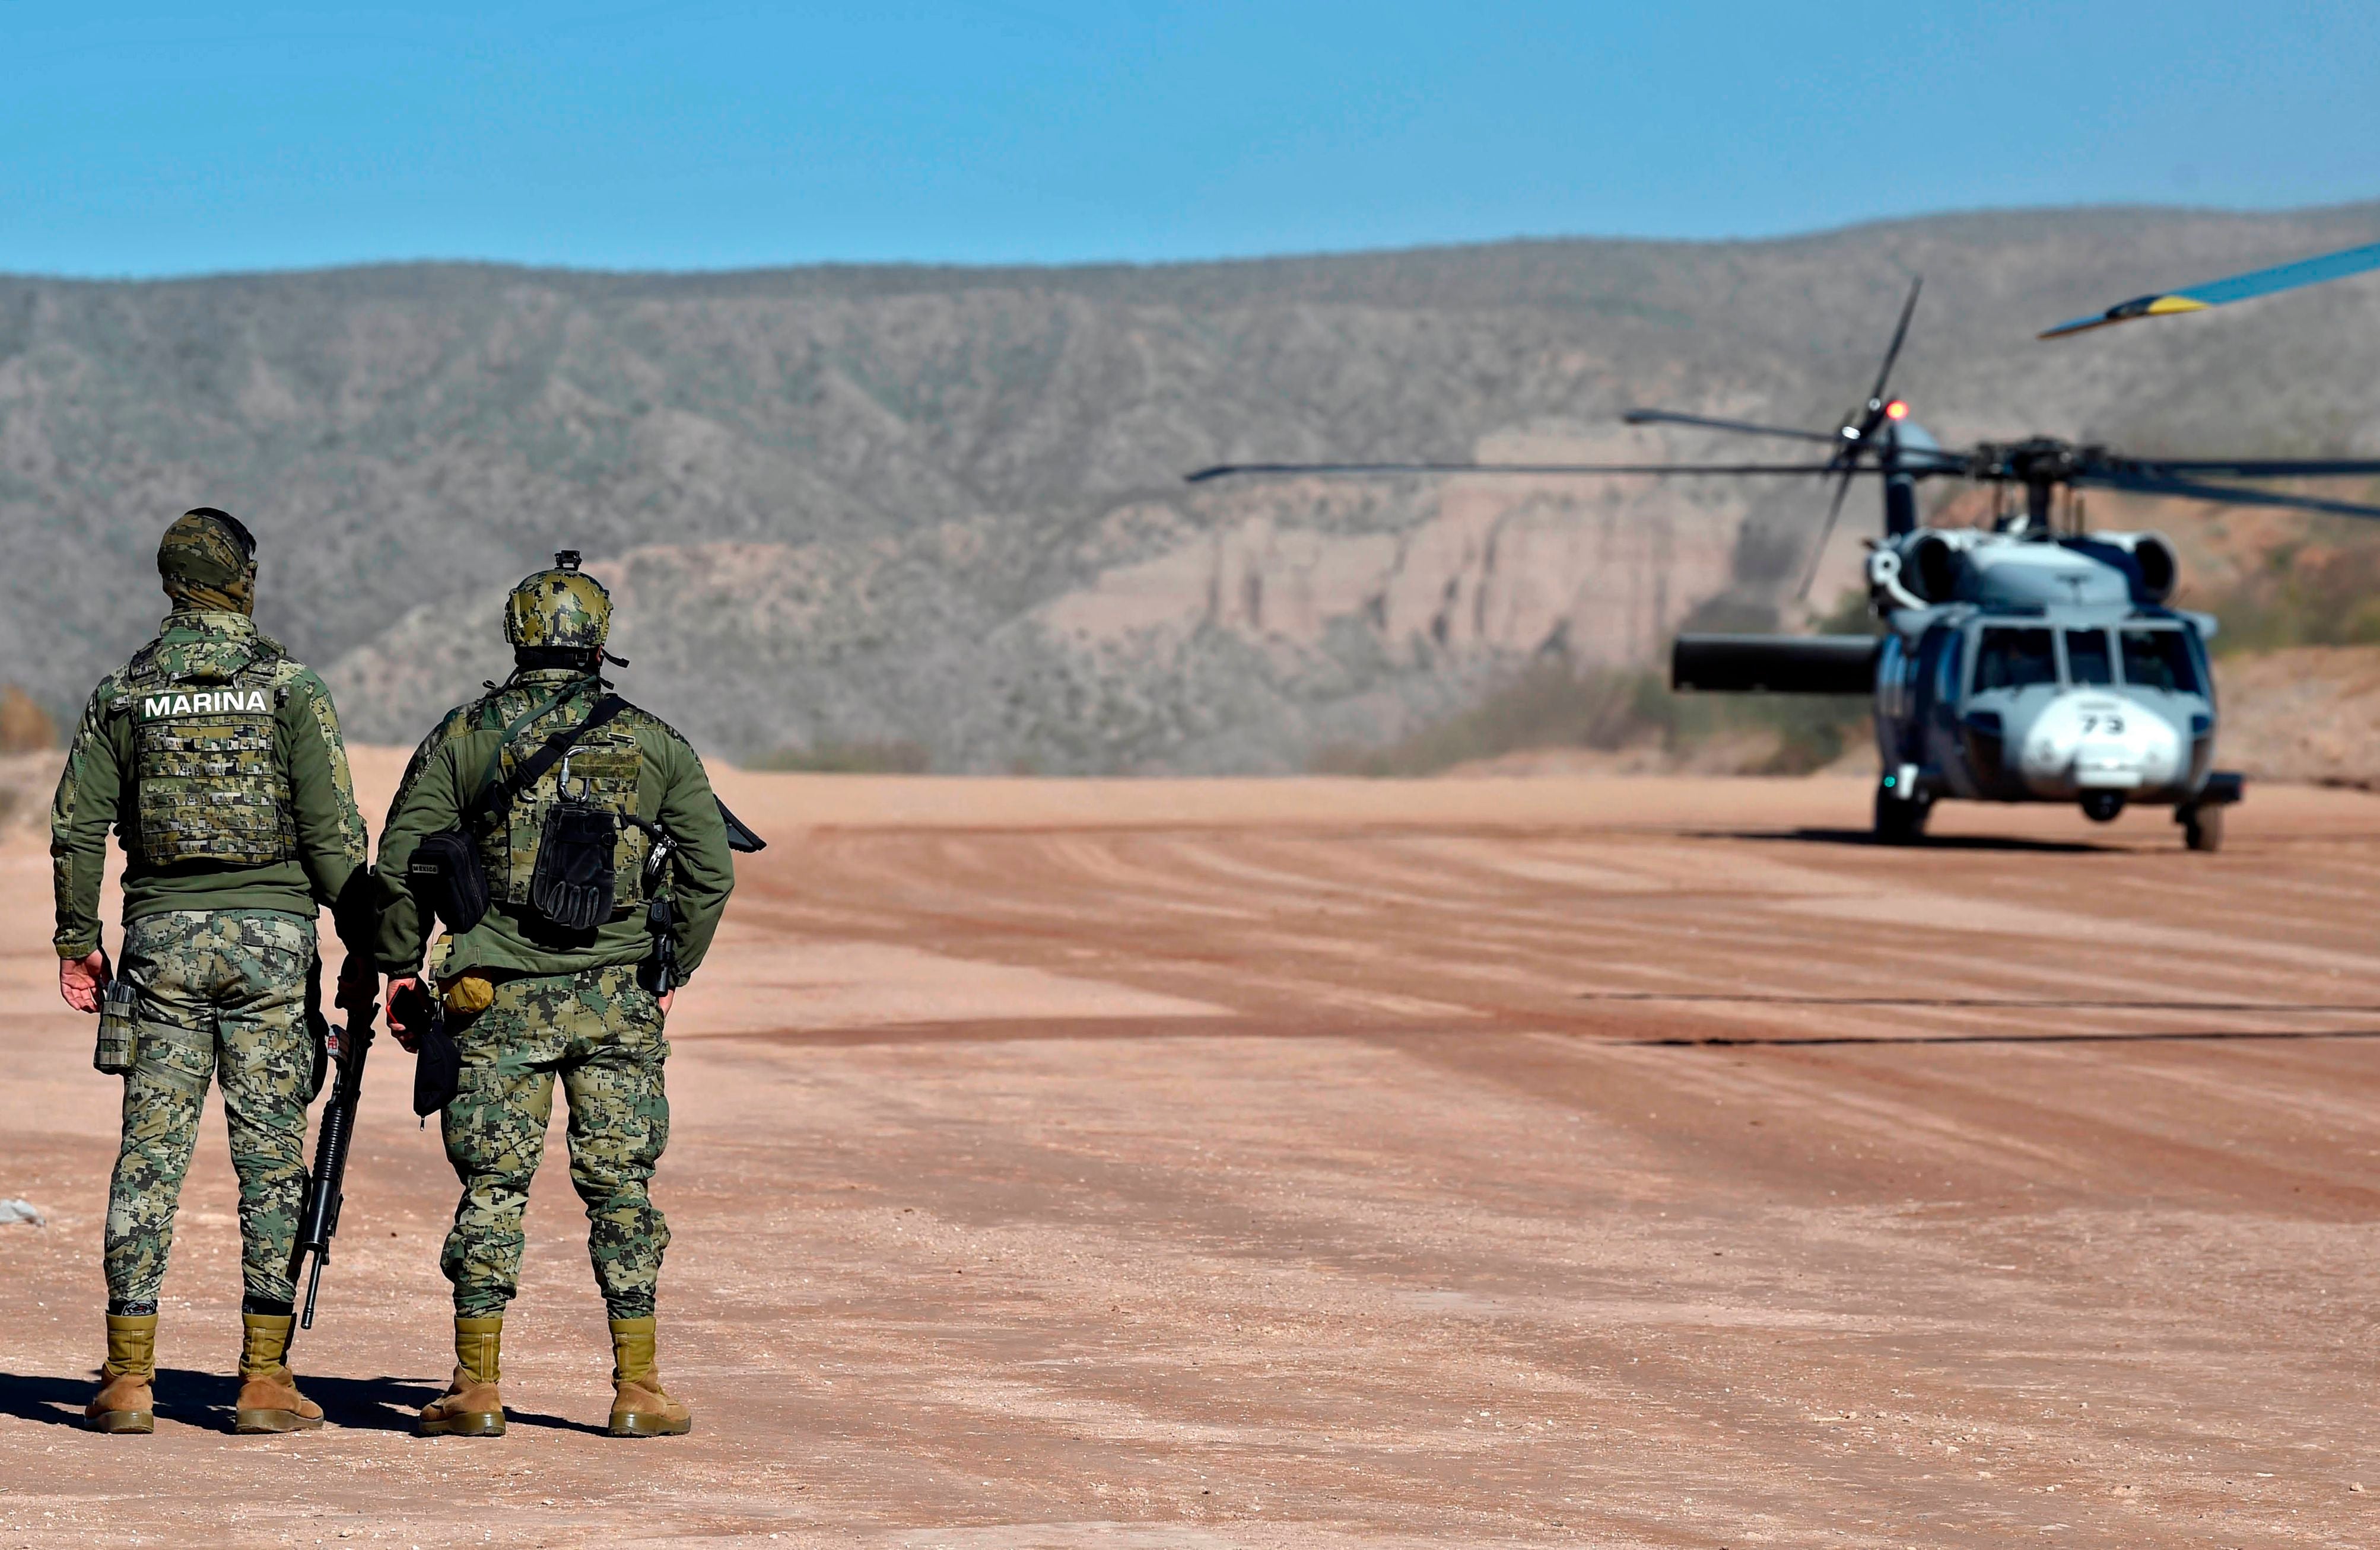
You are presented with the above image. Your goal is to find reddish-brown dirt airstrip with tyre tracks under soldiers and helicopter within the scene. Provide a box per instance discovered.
[0,755,2380,1550]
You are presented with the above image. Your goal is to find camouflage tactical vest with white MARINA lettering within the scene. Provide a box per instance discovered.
[115,641,297,867]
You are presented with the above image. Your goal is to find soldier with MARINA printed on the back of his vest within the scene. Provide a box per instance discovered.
[50,507,376,1431]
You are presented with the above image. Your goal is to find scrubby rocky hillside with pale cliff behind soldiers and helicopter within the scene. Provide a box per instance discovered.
[0,207,2380,771]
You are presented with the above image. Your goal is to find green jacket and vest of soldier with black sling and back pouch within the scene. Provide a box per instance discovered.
[376,667,735,984]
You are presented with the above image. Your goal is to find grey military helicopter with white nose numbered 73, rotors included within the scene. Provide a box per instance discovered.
[1190,281,2380,850]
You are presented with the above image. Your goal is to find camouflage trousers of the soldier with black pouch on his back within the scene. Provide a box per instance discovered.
[440,967,669,1319]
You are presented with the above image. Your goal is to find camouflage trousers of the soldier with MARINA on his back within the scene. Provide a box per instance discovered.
[104,909,314,1307]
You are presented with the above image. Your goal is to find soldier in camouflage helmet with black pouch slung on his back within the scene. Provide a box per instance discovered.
[379,552,735,1436]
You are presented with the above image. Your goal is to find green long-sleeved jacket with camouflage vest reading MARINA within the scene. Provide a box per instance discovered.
[50,610,371,957]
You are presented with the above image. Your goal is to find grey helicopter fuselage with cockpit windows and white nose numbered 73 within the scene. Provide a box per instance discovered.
[1869,531,2216,812]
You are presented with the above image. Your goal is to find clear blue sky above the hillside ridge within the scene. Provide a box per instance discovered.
[0,0,2380,274]
